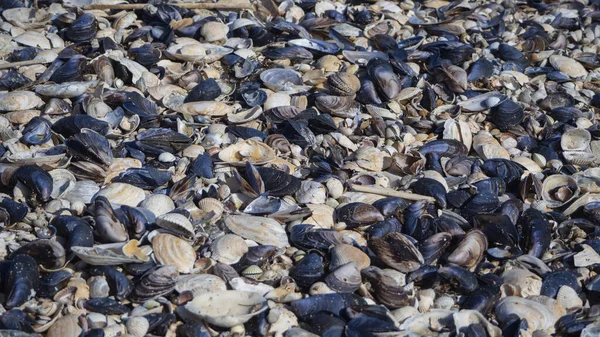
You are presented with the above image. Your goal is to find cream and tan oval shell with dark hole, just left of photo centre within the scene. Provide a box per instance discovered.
[219,139,275,166]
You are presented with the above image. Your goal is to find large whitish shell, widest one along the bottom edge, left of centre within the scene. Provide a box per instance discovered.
[185,290,267,328]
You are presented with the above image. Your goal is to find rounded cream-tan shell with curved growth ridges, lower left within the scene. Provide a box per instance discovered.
[152,233,196,274]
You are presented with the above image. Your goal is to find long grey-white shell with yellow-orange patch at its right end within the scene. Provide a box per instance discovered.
[71,240,150,266]
